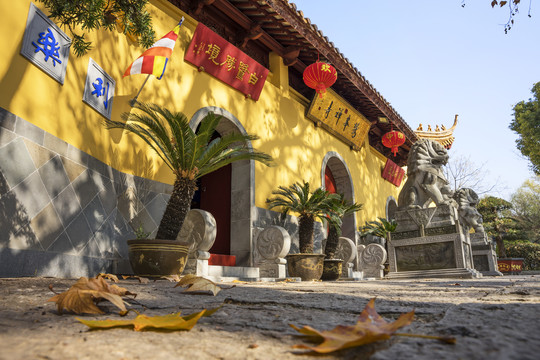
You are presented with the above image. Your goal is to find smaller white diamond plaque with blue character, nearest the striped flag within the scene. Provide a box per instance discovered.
[83,59,116,119]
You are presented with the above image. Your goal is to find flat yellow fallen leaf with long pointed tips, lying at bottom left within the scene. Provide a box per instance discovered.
[77,306,221,331]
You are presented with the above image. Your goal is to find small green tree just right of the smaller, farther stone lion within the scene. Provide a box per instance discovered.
[478,196,523,257]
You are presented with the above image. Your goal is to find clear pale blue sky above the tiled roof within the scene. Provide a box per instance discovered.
[291,0,540,199]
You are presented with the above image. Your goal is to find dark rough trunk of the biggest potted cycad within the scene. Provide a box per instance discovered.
[156,178,197,240]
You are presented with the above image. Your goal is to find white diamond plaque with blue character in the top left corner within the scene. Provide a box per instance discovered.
[21,3,71,84]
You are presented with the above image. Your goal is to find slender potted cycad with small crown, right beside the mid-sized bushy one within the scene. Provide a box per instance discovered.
[321,194,362,281]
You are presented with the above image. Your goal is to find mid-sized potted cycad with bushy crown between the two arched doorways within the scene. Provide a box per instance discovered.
[266,181,339,281]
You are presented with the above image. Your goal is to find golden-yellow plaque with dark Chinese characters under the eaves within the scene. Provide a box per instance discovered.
[307,89,371,150]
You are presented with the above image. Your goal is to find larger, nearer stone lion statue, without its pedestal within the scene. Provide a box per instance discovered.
[398,139,454,209]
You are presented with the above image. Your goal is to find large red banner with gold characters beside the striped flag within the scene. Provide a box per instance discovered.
[184,23,268,100]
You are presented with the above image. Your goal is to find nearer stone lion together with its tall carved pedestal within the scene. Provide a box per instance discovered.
[387,139,483,279]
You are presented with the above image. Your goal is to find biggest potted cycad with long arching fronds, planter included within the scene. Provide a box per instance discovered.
[105,102,272,276]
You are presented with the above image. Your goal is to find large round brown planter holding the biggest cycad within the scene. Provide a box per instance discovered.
[127,239,189,277]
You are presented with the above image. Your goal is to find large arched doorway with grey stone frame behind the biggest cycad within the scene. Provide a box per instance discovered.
[190,106,255,266]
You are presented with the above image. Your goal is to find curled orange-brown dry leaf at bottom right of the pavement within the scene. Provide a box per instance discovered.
[290,299,414,353]
